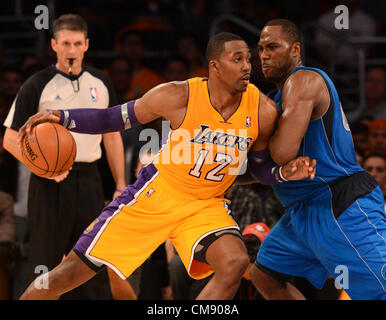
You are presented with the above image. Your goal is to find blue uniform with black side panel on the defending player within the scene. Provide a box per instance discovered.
[256,67,386,299]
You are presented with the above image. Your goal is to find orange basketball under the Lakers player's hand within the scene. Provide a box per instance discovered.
[21,122,76,178]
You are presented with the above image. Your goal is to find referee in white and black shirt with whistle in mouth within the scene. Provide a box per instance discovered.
[4,14,126,299]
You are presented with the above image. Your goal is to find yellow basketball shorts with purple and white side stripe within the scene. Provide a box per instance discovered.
[74,164,239,279]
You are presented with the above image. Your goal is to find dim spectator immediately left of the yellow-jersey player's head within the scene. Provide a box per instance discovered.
[177,35,208,78]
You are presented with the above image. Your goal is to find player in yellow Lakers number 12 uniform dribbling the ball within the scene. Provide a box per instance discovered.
[20,33,315,299]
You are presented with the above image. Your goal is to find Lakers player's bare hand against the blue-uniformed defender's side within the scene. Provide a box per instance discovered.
[281,157,316,180]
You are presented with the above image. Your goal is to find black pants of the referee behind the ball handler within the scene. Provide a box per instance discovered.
[28,162,112,299]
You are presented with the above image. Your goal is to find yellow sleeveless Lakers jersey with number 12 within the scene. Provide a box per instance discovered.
[154,78,259,199]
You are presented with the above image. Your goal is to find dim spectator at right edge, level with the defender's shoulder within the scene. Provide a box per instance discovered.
[365,67,386,119]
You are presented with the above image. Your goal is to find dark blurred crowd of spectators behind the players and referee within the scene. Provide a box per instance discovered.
[0,0,386,299]
